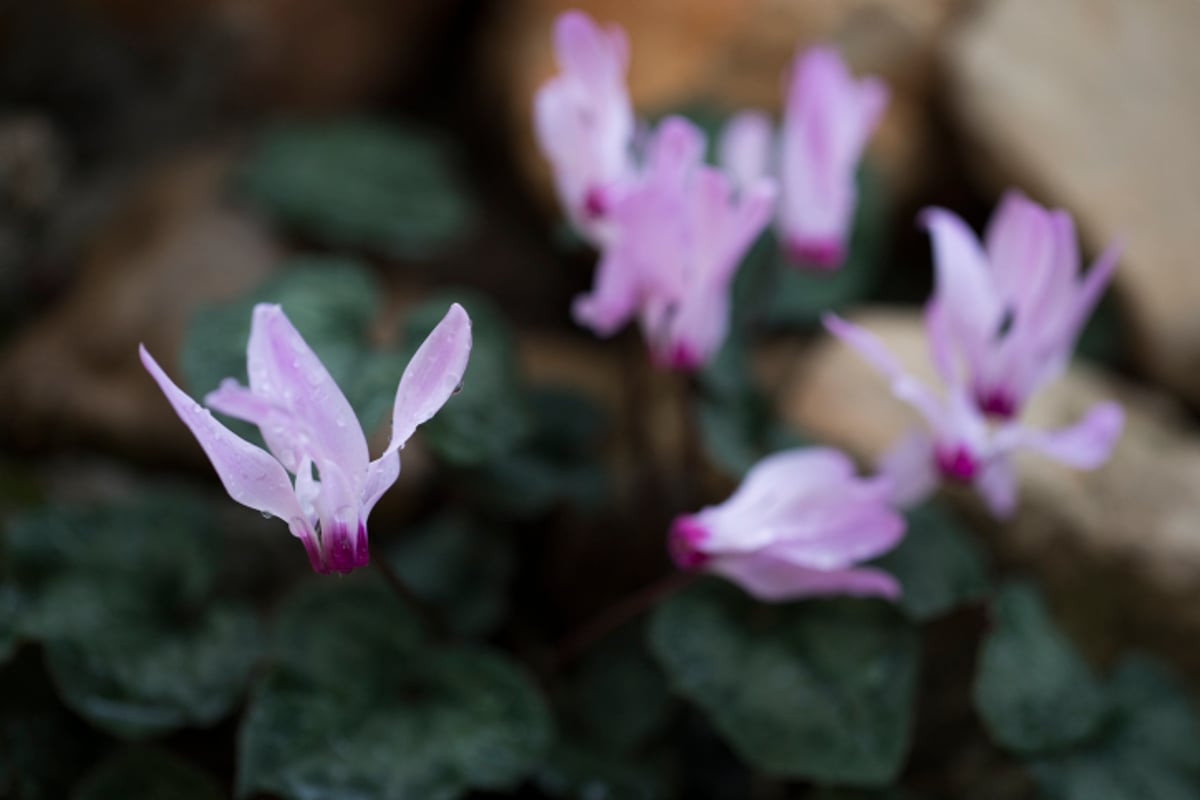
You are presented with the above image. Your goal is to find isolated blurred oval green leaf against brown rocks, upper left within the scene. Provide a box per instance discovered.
[240,120,472,259]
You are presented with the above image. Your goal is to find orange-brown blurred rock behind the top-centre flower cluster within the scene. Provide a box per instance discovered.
[484,0,962,215]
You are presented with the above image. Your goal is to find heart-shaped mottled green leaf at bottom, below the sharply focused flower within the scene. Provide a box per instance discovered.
[238,582,551,800]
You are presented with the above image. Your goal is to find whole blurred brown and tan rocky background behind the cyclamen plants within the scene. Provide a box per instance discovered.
[0,0,1200,796]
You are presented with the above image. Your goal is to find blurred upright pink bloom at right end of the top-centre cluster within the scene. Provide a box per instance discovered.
[779,47,888,270]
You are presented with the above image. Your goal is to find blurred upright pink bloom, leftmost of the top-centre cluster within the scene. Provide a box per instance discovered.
[534,11,634,243]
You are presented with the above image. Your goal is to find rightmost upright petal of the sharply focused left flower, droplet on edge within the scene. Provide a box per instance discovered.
[385,303,470,453]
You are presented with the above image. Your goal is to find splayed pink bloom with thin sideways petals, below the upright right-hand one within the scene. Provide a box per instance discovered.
[824,314,1124,518]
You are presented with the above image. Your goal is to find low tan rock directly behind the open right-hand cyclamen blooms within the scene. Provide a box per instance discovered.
[760,311,1200,675]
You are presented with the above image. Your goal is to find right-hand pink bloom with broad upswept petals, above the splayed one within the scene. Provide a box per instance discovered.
[922,191,1120,419]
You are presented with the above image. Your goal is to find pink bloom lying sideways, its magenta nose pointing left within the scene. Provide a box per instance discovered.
[668,447,905,601]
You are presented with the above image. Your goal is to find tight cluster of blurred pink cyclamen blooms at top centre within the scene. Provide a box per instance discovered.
[534,11,888,371]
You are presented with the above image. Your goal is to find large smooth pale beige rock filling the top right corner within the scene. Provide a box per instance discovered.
[948,0,1200,404]
